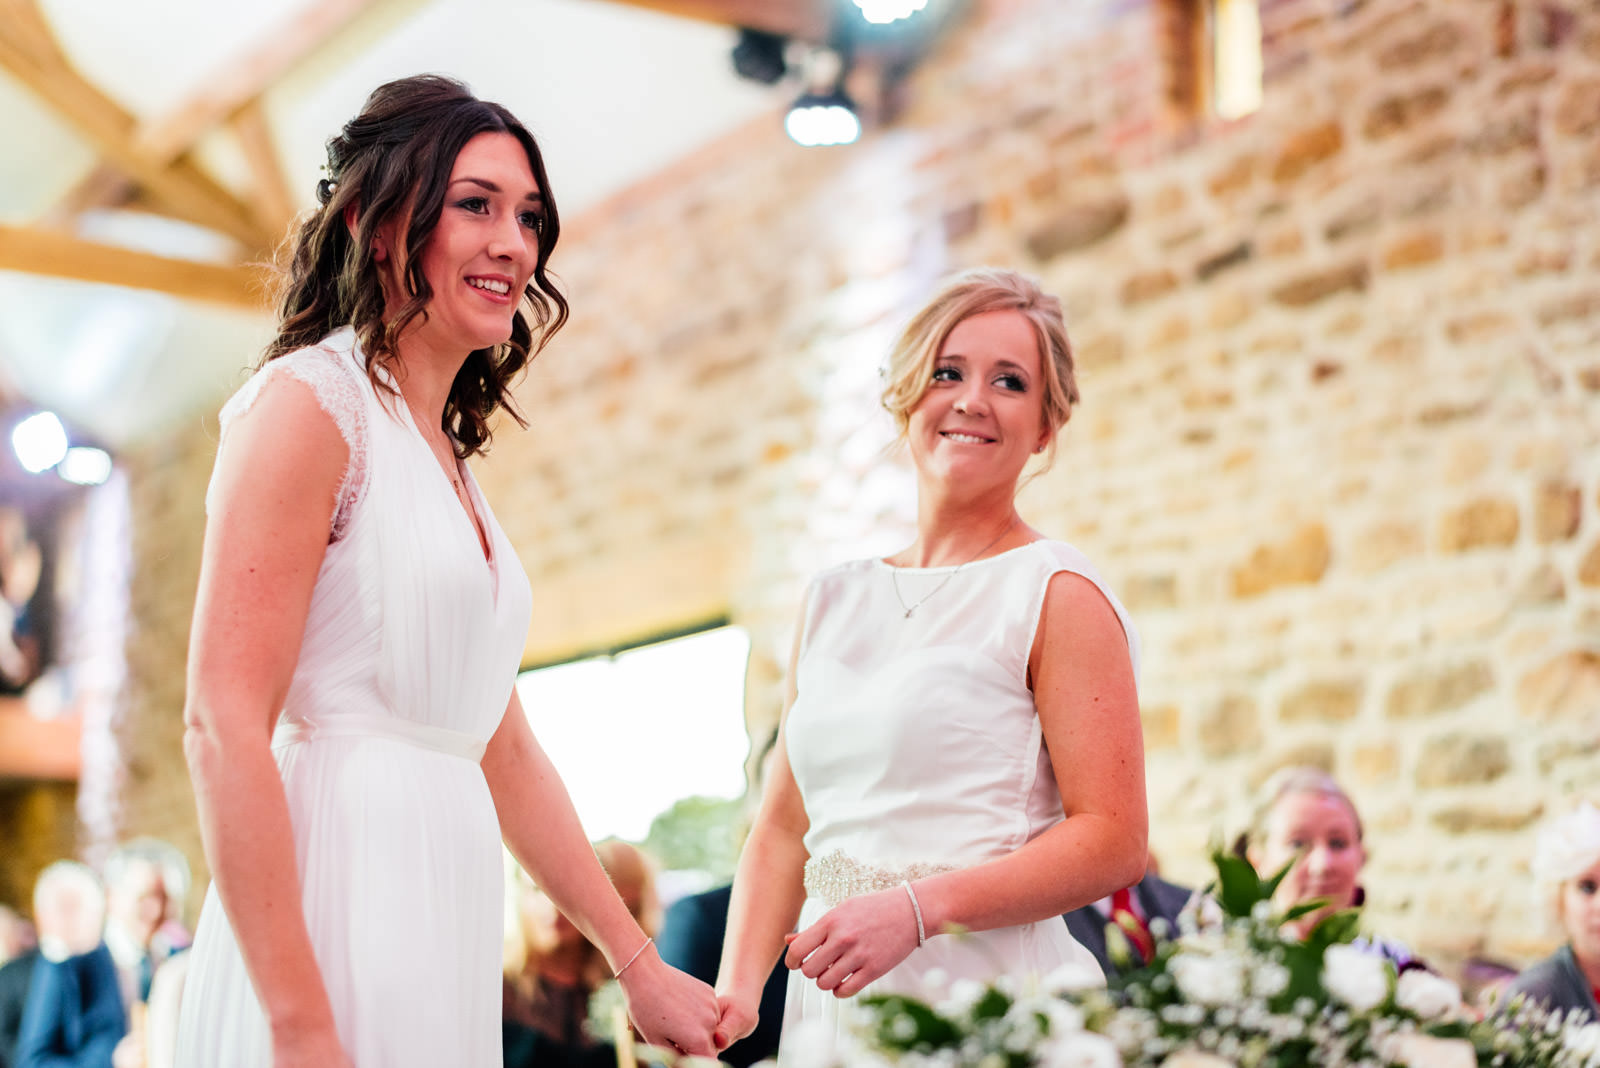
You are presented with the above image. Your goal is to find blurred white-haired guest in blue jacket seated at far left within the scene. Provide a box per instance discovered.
[13,860,128,1068]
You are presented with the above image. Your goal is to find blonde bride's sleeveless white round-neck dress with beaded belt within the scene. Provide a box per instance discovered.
[779,540,1139,1055]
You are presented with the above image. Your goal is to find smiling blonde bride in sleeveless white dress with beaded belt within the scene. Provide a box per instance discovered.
[717,269,1147,1047]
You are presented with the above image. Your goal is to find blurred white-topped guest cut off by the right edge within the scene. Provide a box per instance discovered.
[1507,801,1600,1020]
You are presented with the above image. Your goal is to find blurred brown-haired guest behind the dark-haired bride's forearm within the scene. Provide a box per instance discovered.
[501,838,661,1068]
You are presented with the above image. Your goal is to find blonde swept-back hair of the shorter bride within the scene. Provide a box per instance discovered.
[883,267,1078,462]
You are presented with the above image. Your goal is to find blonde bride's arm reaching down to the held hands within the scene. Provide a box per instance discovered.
[717,612,810,1049]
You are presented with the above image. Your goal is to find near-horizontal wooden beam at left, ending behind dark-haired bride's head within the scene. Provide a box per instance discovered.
[0,224,270,310]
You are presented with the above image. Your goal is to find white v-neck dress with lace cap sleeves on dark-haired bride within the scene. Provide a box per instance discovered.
[178,328,531,1068]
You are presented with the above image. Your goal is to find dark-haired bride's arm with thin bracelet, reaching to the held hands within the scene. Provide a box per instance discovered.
[483,691,717,1055]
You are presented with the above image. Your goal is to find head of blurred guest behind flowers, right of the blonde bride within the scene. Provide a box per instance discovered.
[1235,767,1426,972]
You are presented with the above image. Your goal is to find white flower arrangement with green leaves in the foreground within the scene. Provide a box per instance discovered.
[825,851,1600,1068]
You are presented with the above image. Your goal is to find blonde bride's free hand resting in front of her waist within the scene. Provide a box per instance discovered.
[780,887,917,1012]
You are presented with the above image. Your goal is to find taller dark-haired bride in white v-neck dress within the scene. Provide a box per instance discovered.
[178,77,717,1068]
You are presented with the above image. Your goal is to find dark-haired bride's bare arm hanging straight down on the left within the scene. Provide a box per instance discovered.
[184,374,349,1065]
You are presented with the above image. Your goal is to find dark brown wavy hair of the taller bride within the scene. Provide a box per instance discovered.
[261,75,568,457]
